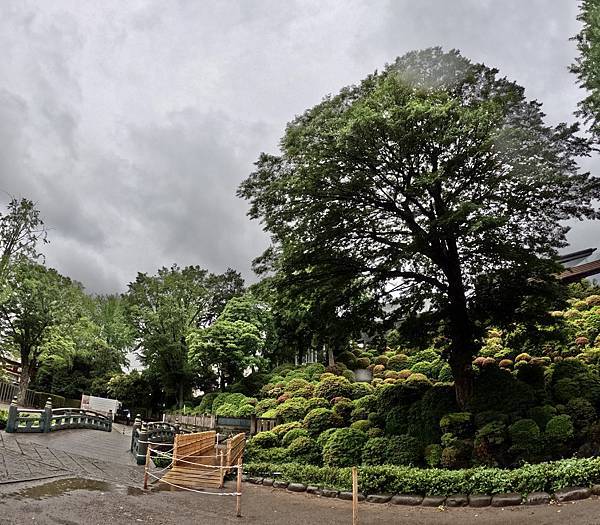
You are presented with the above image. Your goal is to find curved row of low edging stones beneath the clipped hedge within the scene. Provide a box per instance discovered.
[243,476,600,508]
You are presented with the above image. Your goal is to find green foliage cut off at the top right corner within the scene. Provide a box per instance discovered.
[571,0,600,137]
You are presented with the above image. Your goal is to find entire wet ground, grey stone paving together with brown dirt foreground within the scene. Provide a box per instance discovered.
[0,430,600,525]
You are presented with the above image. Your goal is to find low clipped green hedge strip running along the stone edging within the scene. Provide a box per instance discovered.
[244,458,600,496]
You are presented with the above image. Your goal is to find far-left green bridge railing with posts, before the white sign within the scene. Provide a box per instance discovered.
[6,397,112,432]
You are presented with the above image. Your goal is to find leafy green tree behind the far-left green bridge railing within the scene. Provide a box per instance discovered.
[0,260,81,404]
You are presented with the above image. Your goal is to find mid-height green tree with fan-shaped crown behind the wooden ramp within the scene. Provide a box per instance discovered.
[125,265,245,406]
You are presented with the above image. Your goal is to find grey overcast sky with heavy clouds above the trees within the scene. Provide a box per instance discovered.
[0,0,600,292]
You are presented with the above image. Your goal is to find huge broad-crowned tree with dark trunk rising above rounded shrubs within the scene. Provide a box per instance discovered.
[239,48,600,406]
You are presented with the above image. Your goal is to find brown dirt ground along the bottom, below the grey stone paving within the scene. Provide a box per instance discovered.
[0,478,600,525]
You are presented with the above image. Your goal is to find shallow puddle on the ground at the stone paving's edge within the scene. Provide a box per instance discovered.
[6,478,144,500]
